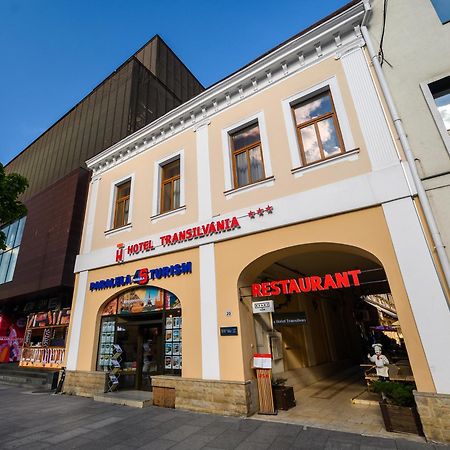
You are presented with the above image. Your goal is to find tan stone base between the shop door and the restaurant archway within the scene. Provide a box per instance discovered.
[152,375,258,416]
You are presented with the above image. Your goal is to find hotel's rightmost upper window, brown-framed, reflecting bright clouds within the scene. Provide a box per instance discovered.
[292,90,344,165]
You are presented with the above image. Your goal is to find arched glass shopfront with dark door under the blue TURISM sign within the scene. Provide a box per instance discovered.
[97,286,182,390]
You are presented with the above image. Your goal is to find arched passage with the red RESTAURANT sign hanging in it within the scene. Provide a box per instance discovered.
[239,243,413,433]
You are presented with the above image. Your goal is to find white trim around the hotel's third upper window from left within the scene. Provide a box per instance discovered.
[222,111,273,192]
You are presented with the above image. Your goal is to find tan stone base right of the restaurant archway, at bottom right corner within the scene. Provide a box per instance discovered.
[414,391,450,444]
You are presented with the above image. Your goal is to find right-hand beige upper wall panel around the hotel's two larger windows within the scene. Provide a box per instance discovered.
[209,58,370,214]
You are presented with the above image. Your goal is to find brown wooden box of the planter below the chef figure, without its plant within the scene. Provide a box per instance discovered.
[380,402,424,436]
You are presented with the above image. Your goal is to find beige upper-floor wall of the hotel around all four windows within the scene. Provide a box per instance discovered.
[82,53,371,250]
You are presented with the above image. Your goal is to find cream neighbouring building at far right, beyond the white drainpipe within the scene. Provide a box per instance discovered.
[367,0,450,439]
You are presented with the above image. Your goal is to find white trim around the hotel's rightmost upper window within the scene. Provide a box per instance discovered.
[281,76,355,168]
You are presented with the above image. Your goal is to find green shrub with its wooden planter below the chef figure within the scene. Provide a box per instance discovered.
[372,381,423,436]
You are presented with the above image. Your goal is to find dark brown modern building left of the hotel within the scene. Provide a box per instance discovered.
[0,36,203,362]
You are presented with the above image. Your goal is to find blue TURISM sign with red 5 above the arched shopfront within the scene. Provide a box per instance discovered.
[89,261,192,291]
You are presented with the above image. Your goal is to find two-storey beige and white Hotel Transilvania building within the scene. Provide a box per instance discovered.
[64,1,450,442]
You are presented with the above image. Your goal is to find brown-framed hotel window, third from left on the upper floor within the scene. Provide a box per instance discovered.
[230,122,265,188]
